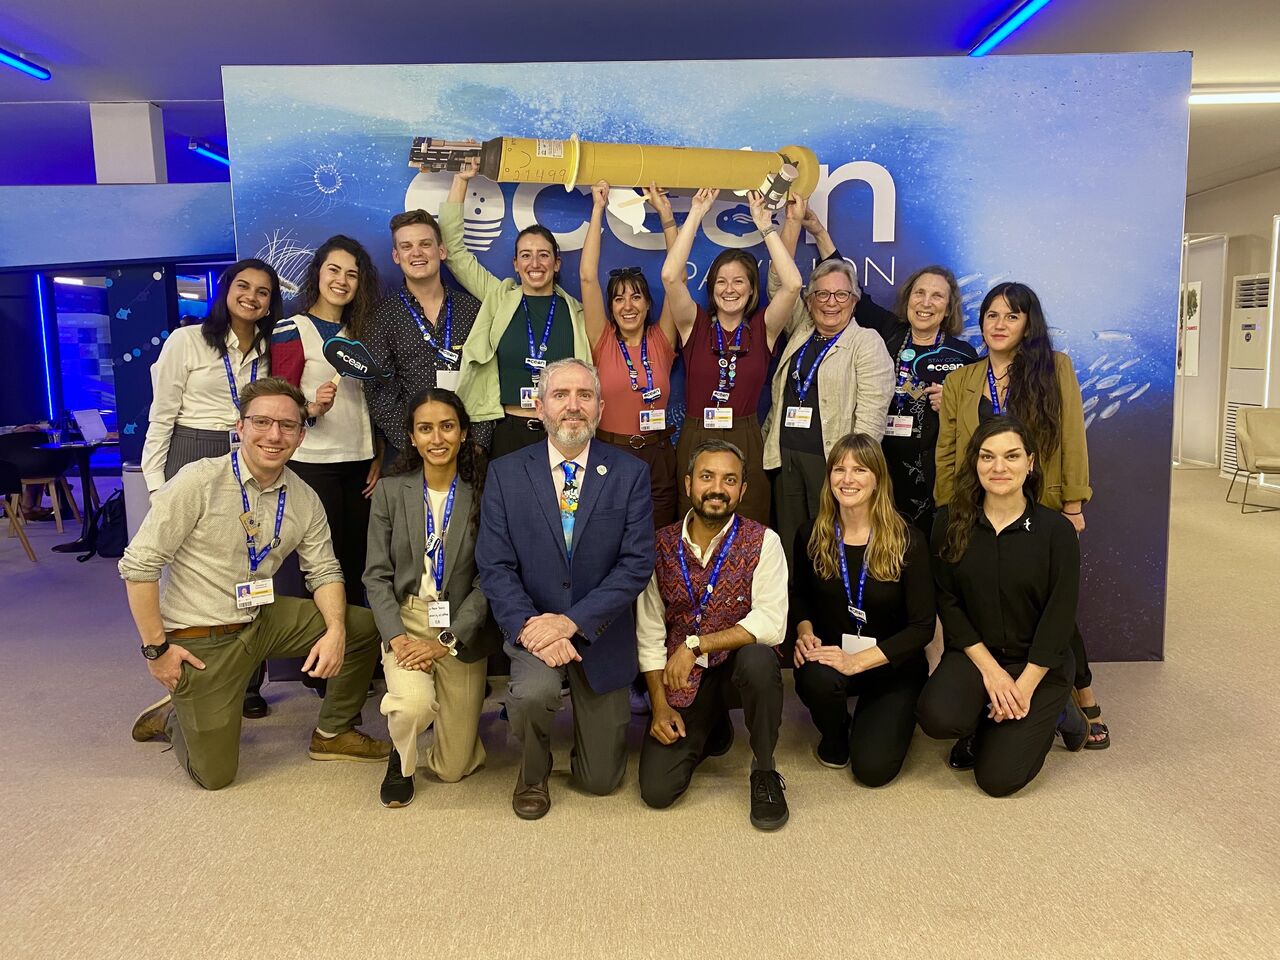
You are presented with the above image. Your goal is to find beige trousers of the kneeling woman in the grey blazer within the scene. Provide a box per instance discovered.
[380,596,486,783]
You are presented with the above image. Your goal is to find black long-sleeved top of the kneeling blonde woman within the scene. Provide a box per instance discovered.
[791,521,937,667]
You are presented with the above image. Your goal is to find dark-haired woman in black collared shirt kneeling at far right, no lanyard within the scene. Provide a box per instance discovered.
[919,416,1089,796]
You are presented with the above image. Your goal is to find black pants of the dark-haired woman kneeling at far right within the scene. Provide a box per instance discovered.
[916,649,1075,796]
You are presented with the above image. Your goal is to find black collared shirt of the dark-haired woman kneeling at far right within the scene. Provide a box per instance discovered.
[933,502,1080,669]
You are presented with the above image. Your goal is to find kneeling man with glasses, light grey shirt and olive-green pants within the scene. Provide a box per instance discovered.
[128,378,390,790]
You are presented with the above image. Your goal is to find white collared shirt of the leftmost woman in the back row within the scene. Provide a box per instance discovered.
[142,324,270,490]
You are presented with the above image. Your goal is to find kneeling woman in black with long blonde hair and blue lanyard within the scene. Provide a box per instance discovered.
[791,434,934,787]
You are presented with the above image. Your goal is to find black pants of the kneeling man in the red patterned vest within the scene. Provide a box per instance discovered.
[640,644,782,808]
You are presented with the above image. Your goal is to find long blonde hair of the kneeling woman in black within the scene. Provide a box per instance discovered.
[809,434,908,584]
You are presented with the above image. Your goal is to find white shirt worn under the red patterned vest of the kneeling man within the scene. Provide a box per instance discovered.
[636,511,787,673]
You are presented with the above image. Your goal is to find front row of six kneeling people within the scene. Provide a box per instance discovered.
[120,358,1089,829]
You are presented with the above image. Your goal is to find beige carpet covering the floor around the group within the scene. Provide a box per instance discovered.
[0,471,1280,960]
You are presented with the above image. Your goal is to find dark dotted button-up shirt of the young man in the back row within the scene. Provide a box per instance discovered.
[365,284,480,451]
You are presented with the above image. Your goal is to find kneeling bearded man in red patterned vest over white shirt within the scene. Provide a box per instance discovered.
[636,440,787,829]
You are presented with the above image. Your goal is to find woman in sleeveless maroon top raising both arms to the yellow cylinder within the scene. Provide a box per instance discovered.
[662,189,801,522]
